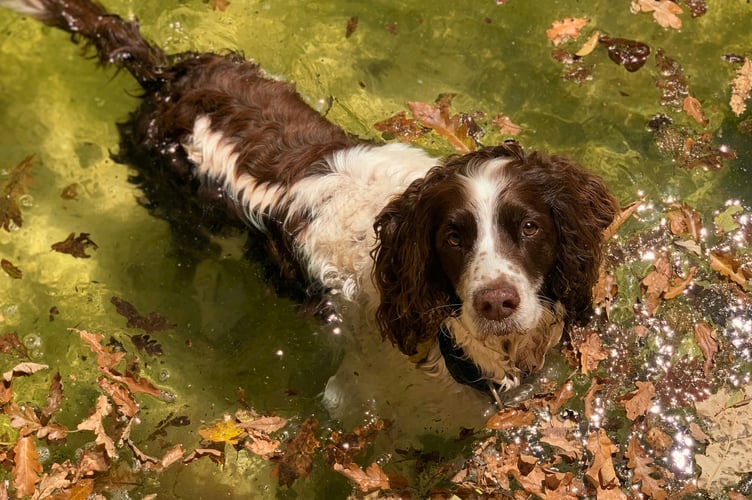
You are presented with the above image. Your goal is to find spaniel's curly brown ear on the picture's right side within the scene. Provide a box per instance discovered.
[528,154,619,323]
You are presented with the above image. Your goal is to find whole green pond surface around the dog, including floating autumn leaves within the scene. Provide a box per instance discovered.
[0,0,752,498]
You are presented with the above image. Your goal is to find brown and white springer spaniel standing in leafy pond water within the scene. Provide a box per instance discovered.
[0,0,617,404]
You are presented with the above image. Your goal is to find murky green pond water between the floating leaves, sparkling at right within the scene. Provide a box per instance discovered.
[0,0,752,498]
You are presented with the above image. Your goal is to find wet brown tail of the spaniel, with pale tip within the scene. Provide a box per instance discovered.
[0,0,168,87]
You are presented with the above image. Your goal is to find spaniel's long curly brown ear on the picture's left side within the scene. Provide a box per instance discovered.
[372,166,452,356]
